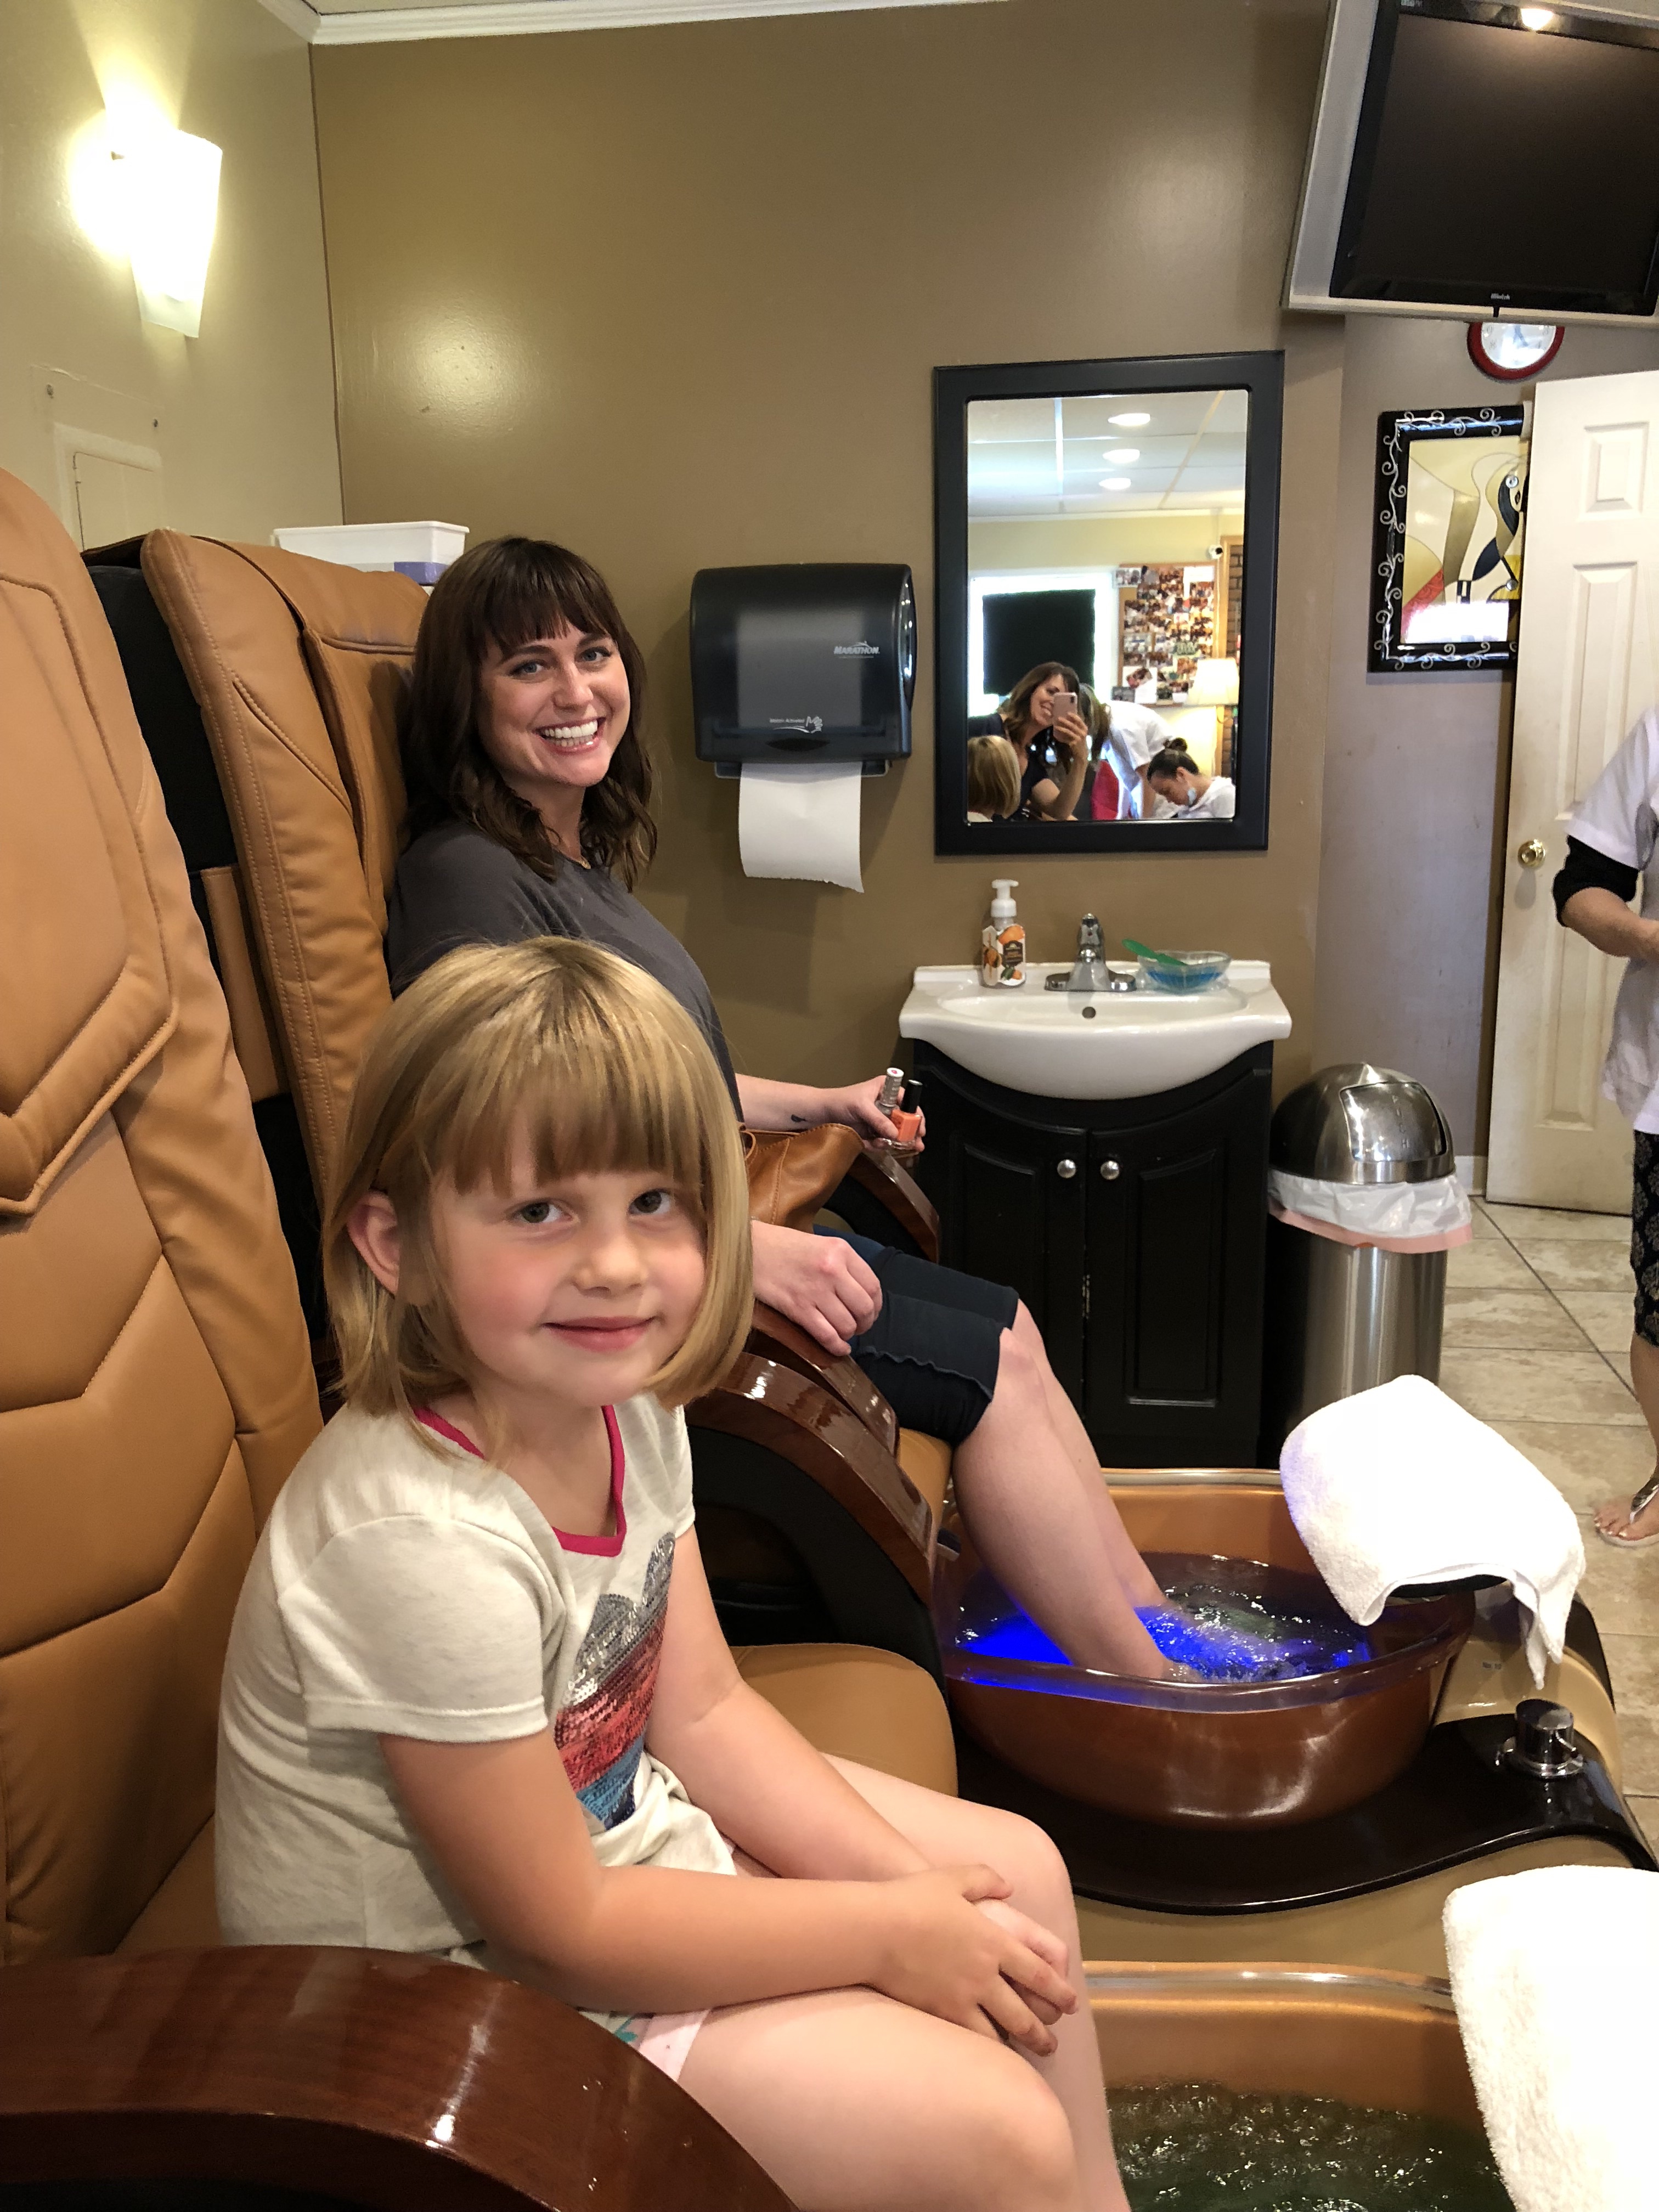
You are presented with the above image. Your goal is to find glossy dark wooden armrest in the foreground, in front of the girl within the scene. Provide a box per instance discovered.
[0,1949,789,2212]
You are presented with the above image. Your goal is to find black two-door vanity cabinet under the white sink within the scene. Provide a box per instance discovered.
[916,1040,1272,1466]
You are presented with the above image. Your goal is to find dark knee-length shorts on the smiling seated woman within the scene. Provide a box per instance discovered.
[821,1230,1020,1447]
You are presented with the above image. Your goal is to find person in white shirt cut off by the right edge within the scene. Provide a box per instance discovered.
[1555,708,1659,1550]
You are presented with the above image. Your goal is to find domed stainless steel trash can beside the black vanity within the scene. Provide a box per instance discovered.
[1263,1062,1455,1464]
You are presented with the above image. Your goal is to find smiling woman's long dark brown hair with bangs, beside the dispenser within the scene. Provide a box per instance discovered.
[400,538,657,889]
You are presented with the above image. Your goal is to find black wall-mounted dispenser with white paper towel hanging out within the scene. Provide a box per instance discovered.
[690,562,916,891]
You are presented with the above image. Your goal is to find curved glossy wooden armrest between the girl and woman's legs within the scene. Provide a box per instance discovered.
[686,1352,936,1604]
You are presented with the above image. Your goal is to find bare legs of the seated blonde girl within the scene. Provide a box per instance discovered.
[681,1758,1128,2212]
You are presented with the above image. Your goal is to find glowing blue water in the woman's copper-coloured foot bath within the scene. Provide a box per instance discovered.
[960,1566,1372,1683]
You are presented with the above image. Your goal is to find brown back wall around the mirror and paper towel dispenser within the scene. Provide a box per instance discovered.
[312,0,1342,1101]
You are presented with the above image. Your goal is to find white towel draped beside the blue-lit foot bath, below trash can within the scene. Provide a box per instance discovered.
[1278,1376,1593,1681]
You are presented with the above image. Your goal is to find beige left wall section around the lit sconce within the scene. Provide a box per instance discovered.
[0,0,341,540]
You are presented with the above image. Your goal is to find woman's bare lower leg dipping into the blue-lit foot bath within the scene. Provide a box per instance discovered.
[951,1307,1172,1679]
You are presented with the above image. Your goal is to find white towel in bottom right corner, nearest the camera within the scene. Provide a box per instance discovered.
[1442,1867,1659,2212]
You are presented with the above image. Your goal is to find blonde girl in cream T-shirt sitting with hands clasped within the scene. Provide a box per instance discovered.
[217,938,1124,2212]
